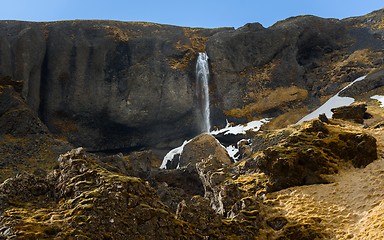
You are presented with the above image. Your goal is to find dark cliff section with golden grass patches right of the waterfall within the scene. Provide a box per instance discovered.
[206,11,384,127]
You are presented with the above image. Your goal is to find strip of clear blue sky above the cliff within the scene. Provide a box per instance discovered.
[0,0,384,28]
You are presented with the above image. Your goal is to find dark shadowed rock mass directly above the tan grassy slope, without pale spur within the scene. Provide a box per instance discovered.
[252,120,377,191]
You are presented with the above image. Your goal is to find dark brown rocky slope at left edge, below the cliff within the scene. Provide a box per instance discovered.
[0,82,71,181]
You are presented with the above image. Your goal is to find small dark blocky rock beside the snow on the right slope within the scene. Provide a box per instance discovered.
[331,104,367,124]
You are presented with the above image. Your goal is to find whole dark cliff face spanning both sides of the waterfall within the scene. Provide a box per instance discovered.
[0,11,384,153]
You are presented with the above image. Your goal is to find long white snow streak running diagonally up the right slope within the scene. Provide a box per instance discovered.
[297,76,366,124]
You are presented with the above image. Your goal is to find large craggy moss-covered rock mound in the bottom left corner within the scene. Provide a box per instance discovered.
[0,148,198,239]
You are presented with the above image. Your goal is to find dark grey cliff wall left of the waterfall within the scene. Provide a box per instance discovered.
[0,21,231,155]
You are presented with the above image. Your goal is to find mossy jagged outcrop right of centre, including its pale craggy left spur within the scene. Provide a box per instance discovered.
[192,120,377,216]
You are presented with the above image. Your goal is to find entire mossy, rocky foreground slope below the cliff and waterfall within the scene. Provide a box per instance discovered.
[0,99,384,239]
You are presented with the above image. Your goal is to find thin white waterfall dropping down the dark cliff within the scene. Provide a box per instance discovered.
[196,53,211,132]
